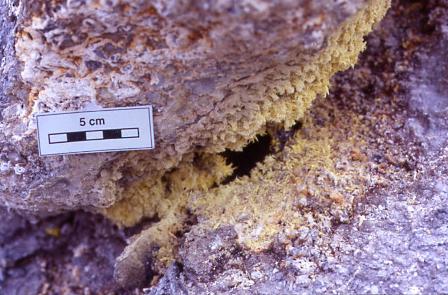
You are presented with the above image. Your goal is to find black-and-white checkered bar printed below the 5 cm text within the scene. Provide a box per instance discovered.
[48,128,140,144]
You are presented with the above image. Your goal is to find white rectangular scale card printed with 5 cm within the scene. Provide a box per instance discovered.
[36,105,155,156]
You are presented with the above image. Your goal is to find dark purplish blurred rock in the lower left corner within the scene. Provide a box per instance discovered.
[0,209,131,294]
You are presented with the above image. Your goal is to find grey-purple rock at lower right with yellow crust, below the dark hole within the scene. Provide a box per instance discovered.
[148,1,448,294]
